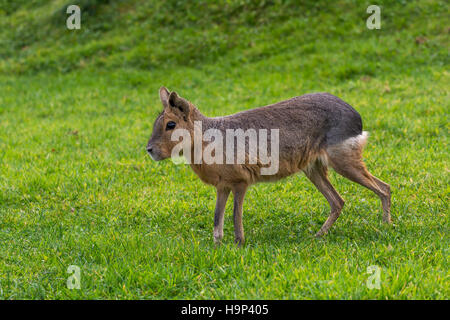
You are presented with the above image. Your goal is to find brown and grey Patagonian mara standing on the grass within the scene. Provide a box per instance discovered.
[147,87,391,244]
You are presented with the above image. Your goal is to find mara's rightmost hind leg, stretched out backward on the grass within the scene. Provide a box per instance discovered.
[327,144,391,223]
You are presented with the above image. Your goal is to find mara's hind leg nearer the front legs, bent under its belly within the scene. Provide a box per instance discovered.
[304,161,344,237]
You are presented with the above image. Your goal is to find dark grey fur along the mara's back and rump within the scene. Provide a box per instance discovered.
[203,93,362,149]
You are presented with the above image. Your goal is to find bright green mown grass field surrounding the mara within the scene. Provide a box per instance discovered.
[0,0,450,299]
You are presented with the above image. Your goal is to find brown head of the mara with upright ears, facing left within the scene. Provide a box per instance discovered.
[147,87,196,161]
